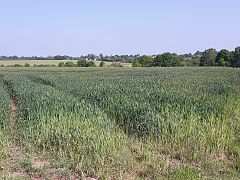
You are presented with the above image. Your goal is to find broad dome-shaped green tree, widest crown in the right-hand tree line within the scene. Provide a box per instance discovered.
[153,52,181,67]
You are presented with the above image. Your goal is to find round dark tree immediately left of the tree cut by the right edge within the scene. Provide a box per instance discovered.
[216,49,234,66]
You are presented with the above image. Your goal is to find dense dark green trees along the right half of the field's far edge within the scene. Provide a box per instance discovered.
[133,47,240,67]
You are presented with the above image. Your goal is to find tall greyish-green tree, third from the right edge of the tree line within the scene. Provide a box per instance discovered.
[200,48,217,66]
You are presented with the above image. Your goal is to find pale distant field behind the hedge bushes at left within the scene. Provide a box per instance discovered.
[0,60,131,66]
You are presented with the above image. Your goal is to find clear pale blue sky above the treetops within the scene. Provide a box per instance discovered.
[0,0,240,56]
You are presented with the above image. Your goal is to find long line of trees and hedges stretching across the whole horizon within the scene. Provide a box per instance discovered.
[0,47,240,67]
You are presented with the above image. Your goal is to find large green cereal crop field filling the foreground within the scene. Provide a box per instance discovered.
[0,67,240,179]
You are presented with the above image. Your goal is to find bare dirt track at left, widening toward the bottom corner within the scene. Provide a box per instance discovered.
[4,81,78,180]
